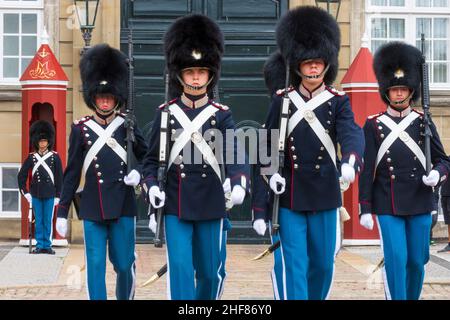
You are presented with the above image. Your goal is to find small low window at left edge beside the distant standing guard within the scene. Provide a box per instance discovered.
[0,164,21,218]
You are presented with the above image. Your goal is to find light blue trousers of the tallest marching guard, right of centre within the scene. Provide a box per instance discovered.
[274,208,340,300]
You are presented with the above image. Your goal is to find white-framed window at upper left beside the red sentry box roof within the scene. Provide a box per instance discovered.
[0,0,42,84]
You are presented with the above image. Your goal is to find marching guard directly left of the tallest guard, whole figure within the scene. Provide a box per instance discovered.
[143,14,248,300]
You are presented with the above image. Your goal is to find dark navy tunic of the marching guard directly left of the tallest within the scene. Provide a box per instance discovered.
[143,97,249,221]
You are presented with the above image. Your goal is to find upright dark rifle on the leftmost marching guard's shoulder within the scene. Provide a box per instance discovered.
[124,27,136,173]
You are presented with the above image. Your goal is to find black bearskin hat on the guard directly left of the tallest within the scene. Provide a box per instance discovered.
[164,14,224,98]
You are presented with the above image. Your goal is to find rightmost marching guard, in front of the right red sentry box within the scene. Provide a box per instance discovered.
[359,42,450,300]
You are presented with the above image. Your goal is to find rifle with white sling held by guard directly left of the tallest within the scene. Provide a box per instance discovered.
[149,72,170,248]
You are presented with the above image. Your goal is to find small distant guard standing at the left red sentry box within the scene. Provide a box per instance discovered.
[17,120,63,254]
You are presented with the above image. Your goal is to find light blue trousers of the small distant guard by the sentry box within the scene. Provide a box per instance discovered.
[32,197,55,249]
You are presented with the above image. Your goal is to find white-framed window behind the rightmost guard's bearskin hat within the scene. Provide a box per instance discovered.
[366,0,450,90]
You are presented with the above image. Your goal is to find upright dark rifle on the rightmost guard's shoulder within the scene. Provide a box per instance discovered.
[420,33,433,174]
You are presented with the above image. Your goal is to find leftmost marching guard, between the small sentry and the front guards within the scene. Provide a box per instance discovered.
[56,44,147,300]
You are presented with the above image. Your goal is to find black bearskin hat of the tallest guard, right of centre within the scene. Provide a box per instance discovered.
[276,6,341,87]
